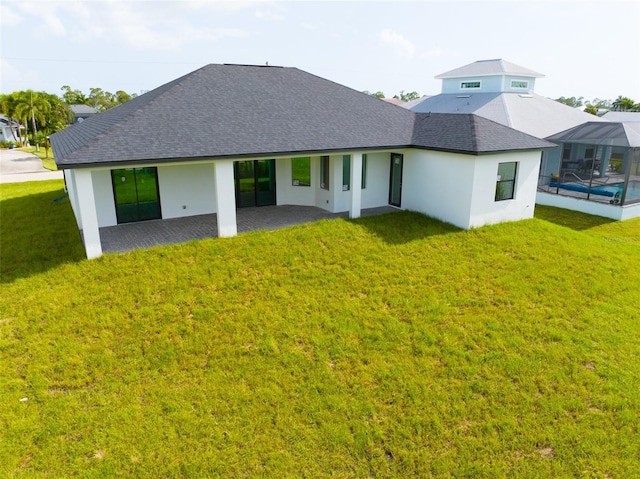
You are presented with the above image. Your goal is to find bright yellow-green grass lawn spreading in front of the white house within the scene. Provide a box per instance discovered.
[0,183,640,478]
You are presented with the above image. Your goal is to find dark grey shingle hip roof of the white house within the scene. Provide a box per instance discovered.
[51,65,548,168]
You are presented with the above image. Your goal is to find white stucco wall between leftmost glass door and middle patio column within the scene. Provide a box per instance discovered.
[158,163,216,219]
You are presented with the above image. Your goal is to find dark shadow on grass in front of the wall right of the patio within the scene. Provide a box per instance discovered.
[351,210,462,244]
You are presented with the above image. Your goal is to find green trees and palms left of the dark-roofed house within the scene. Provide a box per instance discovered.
[0,85,137,149]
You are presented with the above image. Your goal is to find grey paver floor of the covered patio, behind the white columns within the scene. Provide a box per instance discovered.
[100,205,397,253]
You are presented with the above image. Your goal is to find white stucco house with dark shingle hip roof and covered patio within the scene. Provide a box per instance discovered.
[51,65,553,258]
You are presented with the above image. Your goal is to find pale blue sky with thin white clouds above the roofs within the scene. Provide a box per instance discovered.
[0,0,640,101]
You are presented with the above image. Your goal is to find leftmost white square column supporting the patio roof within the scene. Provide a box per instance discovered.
[74,169,102,259]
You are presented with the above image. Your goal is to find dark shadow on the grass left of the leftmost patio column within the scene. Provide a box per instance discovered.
[0,185,85,283]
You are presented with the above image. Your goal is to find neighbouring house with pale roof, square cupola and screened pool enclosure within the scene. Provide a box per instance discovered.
[402,59,640,219]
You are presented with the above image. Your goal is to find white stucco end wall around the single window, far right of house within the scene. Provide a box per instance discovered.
[469,151,540,227]
